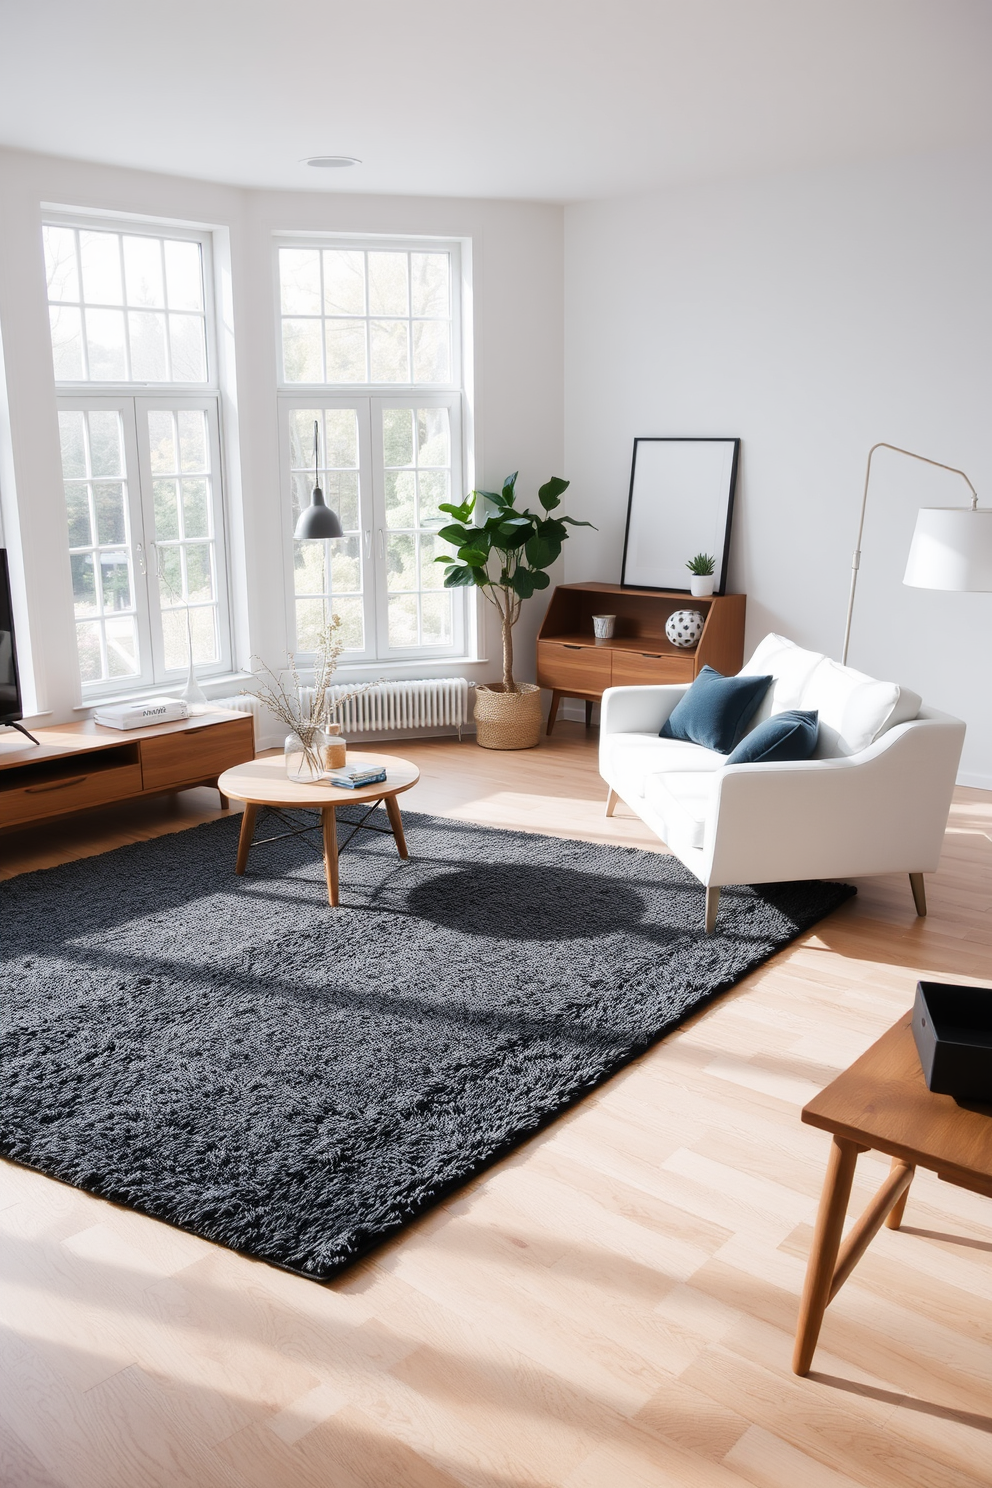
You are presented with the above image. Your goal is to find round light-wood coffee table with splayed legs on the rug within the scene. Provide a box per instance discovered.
[217,750,421,905]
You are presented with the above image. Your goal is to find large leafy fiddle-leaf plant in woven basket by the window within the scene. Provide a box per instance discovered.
[436,472,593,748]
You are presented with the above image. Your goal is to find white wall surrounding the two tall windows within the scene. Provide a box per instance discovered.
[0,150,562,723]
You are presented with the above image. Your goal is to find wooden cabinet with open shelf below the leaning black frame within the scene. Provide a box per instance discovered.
[537,583,747,734]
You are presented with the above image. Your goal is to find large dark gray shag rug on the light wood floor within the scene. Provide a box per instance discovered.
[0,808,854,1278]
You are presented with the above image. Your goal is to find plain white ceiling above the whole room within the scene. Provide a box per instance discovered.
[0,0,992,201]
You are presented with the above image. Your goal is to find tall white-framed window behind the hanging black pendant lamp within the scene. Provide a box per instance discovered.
[277,243,467,662]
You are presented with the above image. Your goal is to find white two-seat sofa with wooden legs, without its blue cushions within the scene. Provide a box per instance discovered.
[599,635,965,933]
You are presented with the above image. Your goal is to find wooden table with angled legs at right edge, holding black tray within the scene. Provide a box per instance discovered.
[793,1012,992,1375]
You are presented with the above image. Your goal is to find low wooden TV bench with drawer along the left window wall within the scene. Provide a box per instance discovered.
[0,708,254,830]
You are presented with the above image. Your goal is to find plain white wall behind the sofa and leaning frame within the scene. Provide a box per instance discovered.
[564,153,992,791]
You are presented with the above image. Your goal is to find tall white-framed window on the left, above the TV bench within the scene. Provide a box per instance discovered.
[43,222,231,698]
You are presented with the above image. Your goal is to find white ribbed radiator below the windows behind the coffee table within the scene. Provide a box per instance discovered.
[214,677,468,743]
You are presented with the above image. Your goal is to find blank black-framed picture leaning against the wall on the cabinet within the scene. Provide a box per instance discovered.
[620,439,741,594]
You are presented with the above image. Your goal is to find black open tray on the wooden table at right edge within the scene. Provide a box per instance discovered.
[913,982,992,1101]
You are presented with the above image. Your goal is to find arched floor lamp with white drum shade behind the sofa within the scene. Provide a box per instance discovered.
[840,440,992,665]
